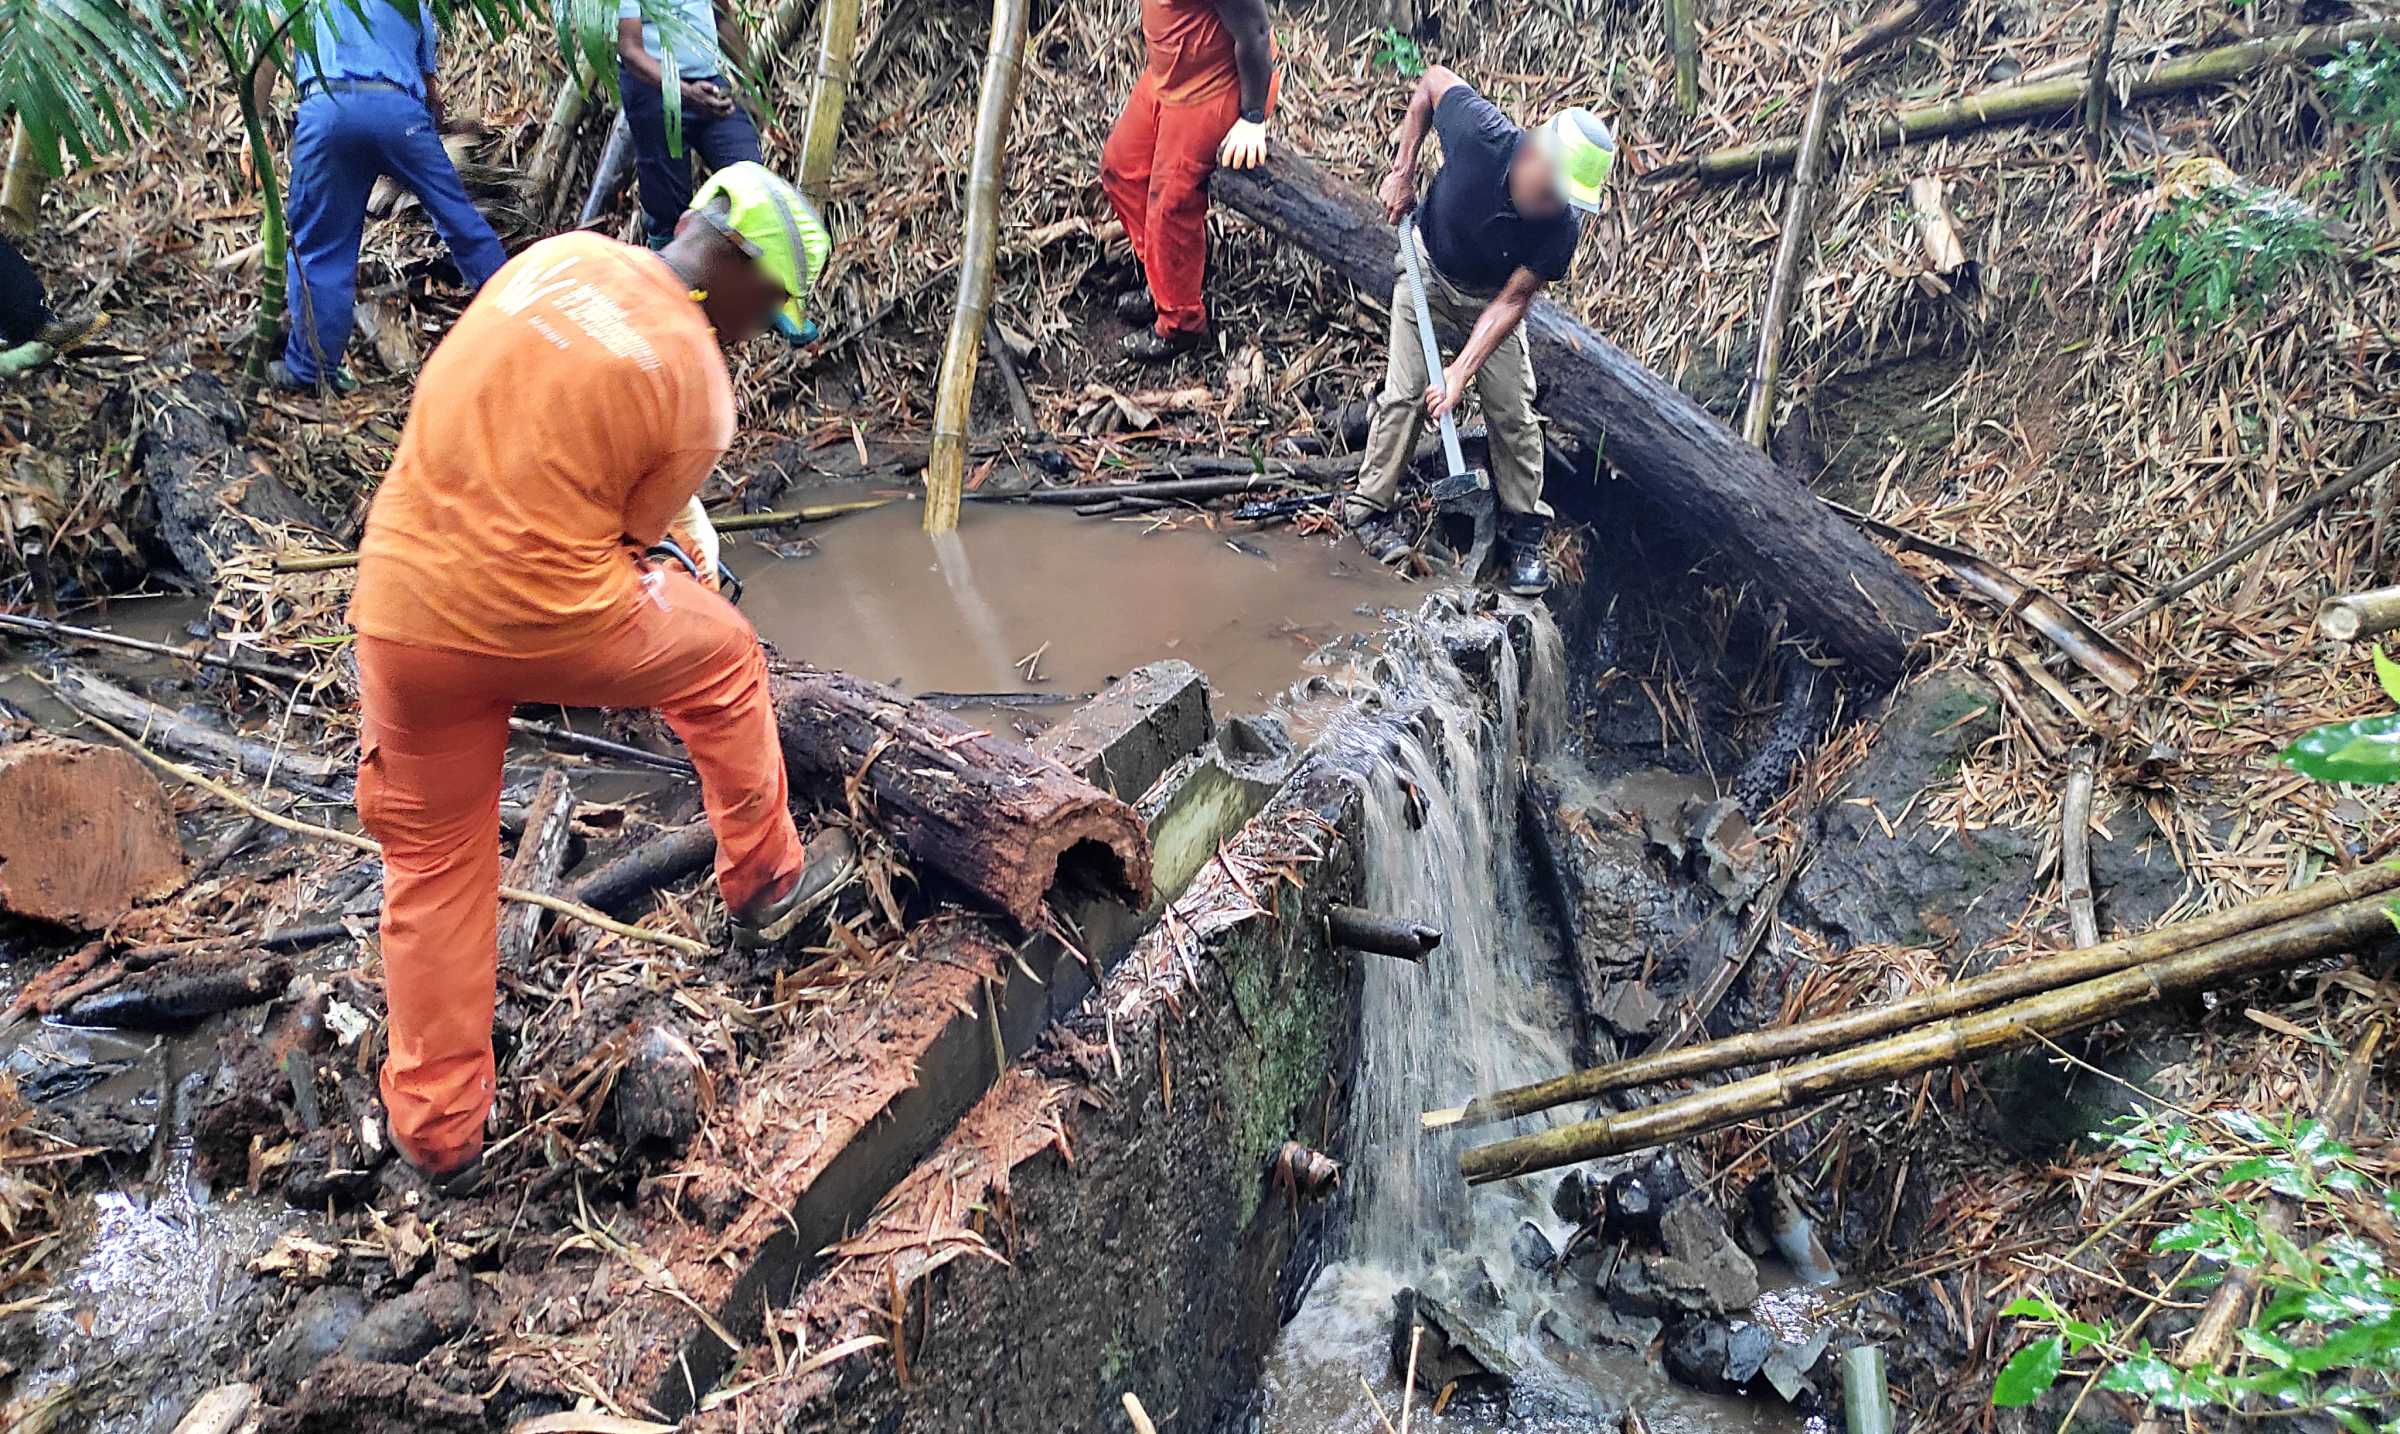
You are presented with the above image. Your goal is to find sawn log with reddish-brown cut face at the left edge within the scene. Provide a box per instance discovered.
[0,736,182,930]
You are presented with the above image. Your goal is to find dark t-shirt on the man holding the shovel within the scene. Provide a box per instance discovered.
[1416,84,1584,295]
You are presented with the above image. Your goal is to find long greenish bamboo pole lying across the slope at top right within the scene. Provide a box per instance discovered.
[1649,19,2400,180]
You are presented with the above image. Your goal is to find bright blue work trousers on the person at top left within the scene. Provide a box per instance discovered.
[283,89,509,384]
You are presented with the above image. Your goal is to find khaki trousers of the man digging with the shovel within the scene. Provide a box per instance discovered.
[1351,228,1550,518]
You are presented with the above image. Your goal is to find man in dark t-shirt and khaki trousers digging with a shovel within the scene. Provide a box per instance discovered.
[1342,65,1618,595]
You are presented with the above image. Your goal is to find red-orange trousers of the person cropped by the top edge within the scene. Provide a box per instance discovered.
[1099,70,1241,333]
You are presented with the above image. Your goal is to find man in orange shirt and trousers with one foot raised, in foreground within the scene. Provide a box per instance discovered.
[350,163,854,1192]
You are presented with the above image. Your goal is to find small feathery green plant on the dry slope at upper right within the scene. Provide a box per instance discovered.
[2117,185,2340,333]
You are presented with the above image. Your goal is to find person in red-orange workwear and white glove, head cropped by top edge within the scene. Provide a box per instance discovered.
[1099,0,1274,364]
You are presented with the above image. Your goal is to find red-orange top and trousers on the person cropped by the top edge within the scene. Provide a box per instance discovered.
[1099,0,1274,333]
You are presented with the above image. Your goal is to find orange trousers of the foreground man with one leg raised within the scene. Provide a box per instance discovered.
[358,573,806,1173]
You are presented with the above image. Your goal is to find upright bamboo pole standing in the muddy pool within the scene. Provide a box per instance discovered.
[924,0,1027,535]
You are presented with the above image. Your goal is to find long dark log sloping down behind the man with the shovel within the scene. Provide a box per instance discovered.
[1210,146,1942,681]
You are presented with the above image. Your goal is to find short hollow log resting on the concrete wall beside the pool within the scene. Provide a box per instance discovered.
[775,667,1150,928]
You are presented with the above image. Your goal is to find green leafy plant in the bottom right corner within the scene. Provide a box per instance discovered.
[1992,1110,2400,1434]
